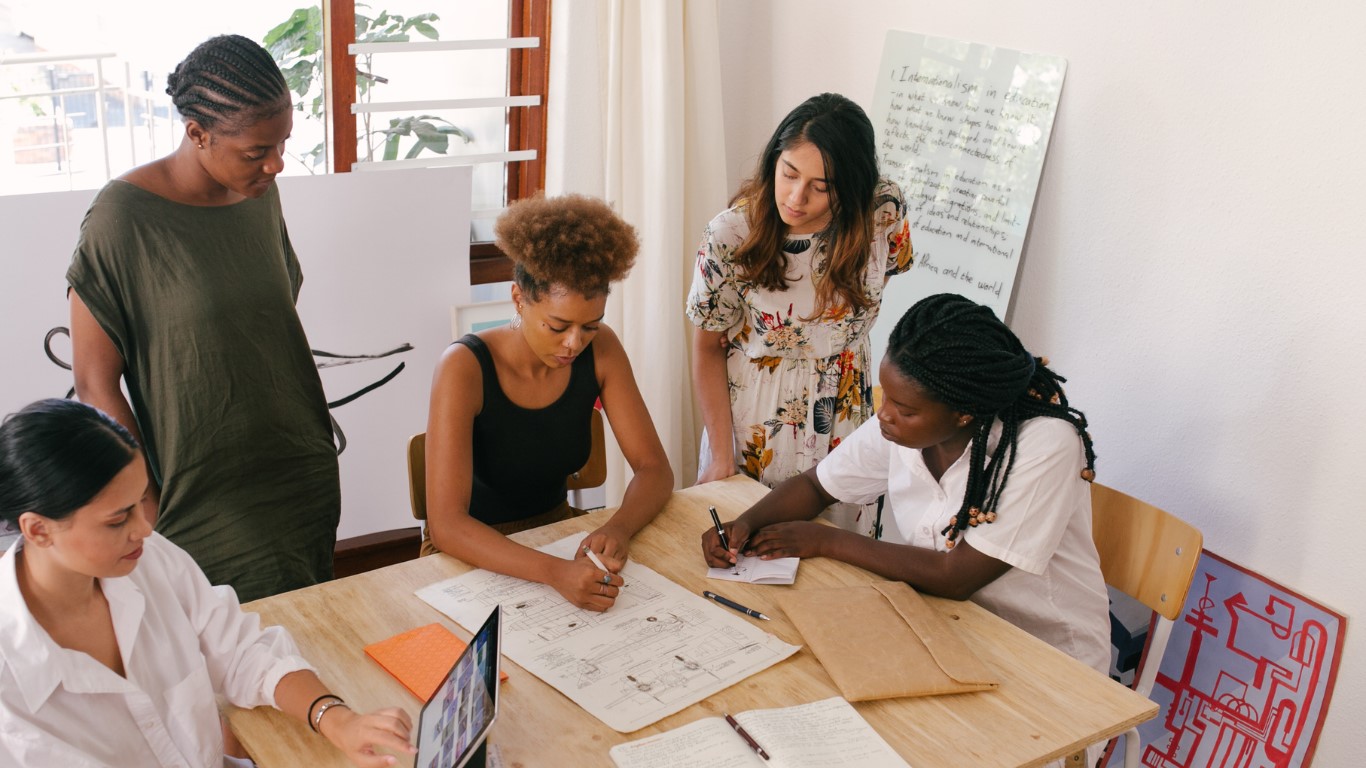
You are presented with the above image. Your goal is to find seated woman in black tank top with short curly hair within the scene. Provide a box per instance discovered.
[423,195,673,611]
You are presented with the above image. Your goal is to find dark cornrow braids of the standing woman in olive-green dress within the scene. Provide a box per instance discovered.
[167,34,290,133]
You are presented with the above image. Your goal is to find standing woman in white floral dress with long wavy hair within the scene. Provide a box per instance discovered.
[687,93,911,533]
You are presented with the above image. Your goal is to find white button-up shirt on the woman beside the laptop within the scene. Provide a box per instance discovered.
[0,533,311,768]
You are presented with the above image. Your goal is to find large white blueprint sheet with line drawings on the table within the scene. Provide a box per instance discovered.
[417,534,798,732]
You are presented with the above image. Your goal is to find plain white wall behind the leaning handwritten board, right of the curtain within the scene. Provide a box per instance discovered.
[721,0,1366,765]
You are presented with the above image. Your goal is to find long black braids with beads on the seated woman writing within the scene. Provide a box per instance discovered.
[887,294,1096,548]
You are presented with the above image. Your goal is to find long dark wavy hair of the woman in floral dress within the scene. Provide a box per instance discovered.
[731,93,878,317]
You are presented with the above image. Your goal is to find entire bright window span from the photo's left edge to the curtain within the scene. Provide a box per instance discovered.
[0,0,550,283]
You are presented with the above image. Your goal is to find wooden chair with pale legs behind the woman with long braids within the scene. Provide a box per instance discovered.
[1091,482,1205,768]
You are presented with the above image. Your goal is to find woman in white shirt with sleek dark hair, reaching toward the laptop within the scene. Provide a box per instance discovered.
[0,400,414,768]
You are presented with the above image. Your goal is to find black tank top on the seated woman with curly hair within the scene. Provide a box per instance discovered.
[455,333,598,523]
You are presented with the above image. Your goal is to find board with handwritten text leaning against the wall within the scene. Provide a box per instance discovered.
[870,30,1067,359]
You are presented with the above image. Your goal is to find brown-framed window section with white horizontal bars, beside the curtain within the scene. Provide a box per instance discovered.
[326,0,550,284]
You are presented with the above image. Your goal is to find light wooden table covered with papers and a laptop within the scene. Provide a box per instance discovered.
[228,477,1157,768]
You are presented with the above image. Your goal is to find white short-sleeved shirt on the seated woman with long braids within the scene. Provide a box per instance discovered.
[816,417,1109,672]
